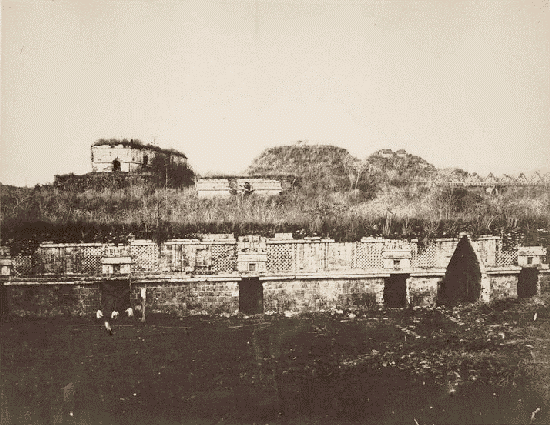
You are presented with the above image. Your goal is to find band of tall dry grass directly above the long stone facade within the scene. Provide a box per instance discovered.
[1,181,550,250]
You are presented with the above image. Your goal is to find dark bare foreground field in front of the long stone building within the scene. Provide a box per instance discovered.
[0,298,550,425]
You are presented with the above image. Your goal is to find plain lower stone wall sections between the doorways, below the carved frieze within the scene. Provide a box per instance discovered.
[1,267,550,317]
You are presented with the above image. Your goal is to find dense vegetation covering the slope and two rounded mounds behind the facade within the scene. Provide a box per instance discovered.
[1,145,550,252]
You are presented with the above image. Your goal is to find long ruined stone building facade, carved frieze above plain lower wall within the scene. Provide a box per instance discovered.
[0,234,550,316]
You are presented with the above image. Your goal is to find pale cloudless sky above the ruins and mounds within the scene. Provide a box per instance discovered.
[0,0,550,186]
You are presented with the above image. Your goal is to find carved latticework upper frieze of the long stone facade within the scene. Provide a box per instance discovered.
[6,235,528,276]
